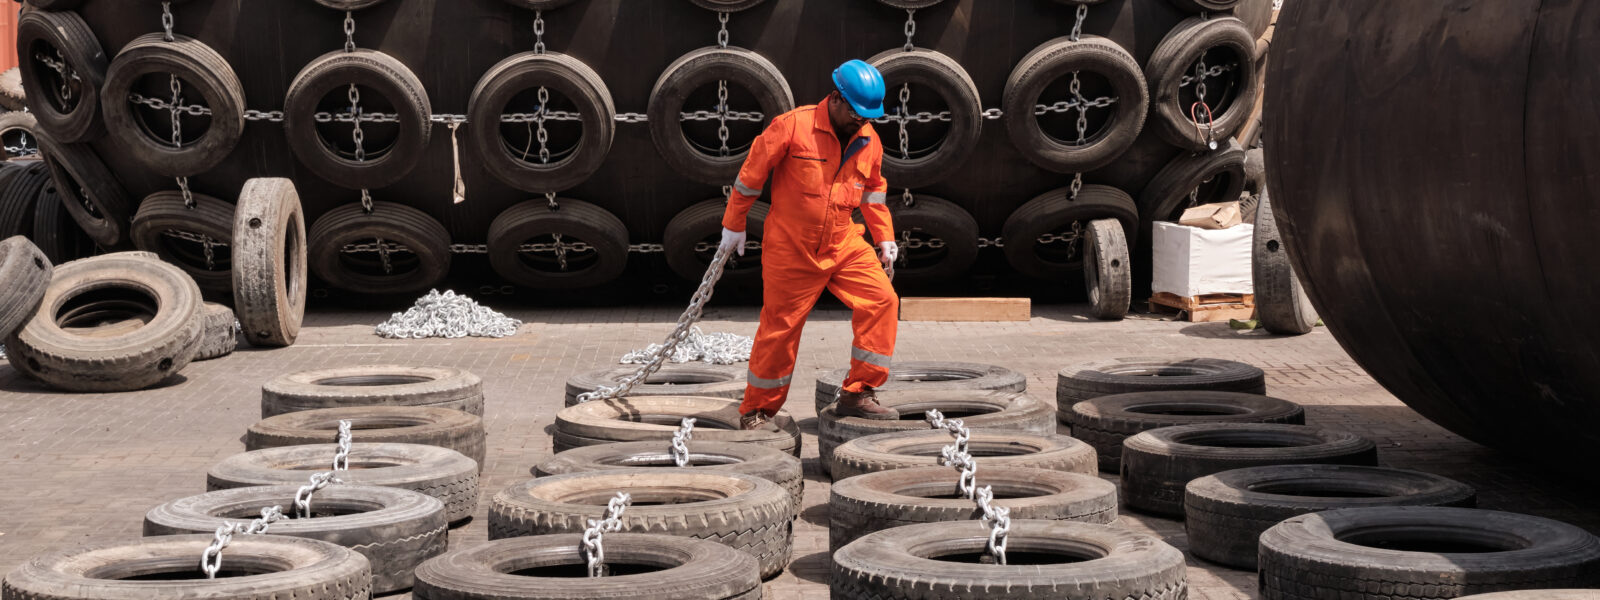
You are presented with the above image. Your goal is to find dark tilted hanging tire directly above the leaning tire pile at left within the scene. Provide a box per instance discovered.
[38,131,131,248]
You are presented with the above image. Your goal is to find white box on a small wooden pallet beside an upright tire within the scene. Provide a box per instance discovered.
[1150,222,1256,298]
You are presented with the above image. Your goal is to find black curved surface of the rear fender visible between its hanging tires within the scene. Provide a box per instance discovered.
[25,0,1270,300]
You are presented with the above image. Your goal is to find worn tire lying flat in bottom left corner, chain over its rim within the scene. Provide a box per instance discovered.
[5,531,373,600]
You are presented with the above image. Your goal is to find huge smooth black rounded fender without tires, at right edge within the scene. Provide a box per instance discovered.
[1264,0,1600,464]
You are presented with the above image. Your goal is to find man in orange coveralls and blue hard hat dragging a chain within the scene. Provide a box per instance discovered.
[720,61,899,429]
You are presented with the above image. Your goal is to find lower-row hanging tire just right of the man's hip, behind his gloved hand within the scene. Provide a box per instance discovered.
[885,194,978,285]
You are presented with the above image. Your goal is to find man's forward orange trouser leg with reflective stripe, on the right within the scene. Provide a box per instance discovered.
[827,240,899,392]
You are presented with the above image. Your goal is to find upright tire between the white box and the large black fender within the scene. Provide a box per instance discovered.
[1250,190,1317,334]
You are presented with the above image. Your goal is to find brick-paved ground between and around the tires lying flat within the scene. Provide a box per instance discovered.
[0,306,1600,600]
